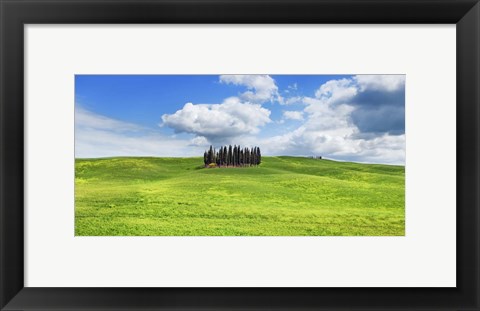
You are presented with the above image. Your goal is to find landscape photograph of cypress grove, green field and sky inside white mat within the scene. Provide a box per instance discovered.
[74,74,406,236]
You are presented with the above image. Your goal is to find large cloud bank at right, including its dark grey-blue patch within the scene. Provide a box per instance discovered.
[253,76,405,164]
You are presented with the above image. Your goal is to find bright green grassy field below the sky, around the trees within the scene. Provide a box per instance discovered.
[75,157,405,236]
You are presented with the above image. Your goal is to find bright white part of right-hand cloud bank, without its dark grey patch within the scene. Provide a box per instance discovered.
[253,78,405,164]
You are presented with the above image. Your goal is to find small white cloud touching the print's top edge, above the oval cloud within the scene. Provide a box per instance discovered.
[220,75,282,103]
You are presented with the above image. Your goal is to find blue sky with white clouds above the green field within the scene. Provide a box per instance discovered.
[75,75,405,164]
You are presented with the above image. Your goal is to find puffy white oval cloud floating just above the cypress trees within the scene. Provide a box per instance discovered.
[162,97,271,141]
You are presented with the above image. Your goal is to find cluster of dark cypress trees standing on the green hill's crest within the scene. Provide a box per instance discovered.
[203,145,262,167]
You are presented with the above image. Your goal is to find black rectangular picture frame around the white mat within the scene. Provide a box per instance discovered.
[0,0,480,310]
